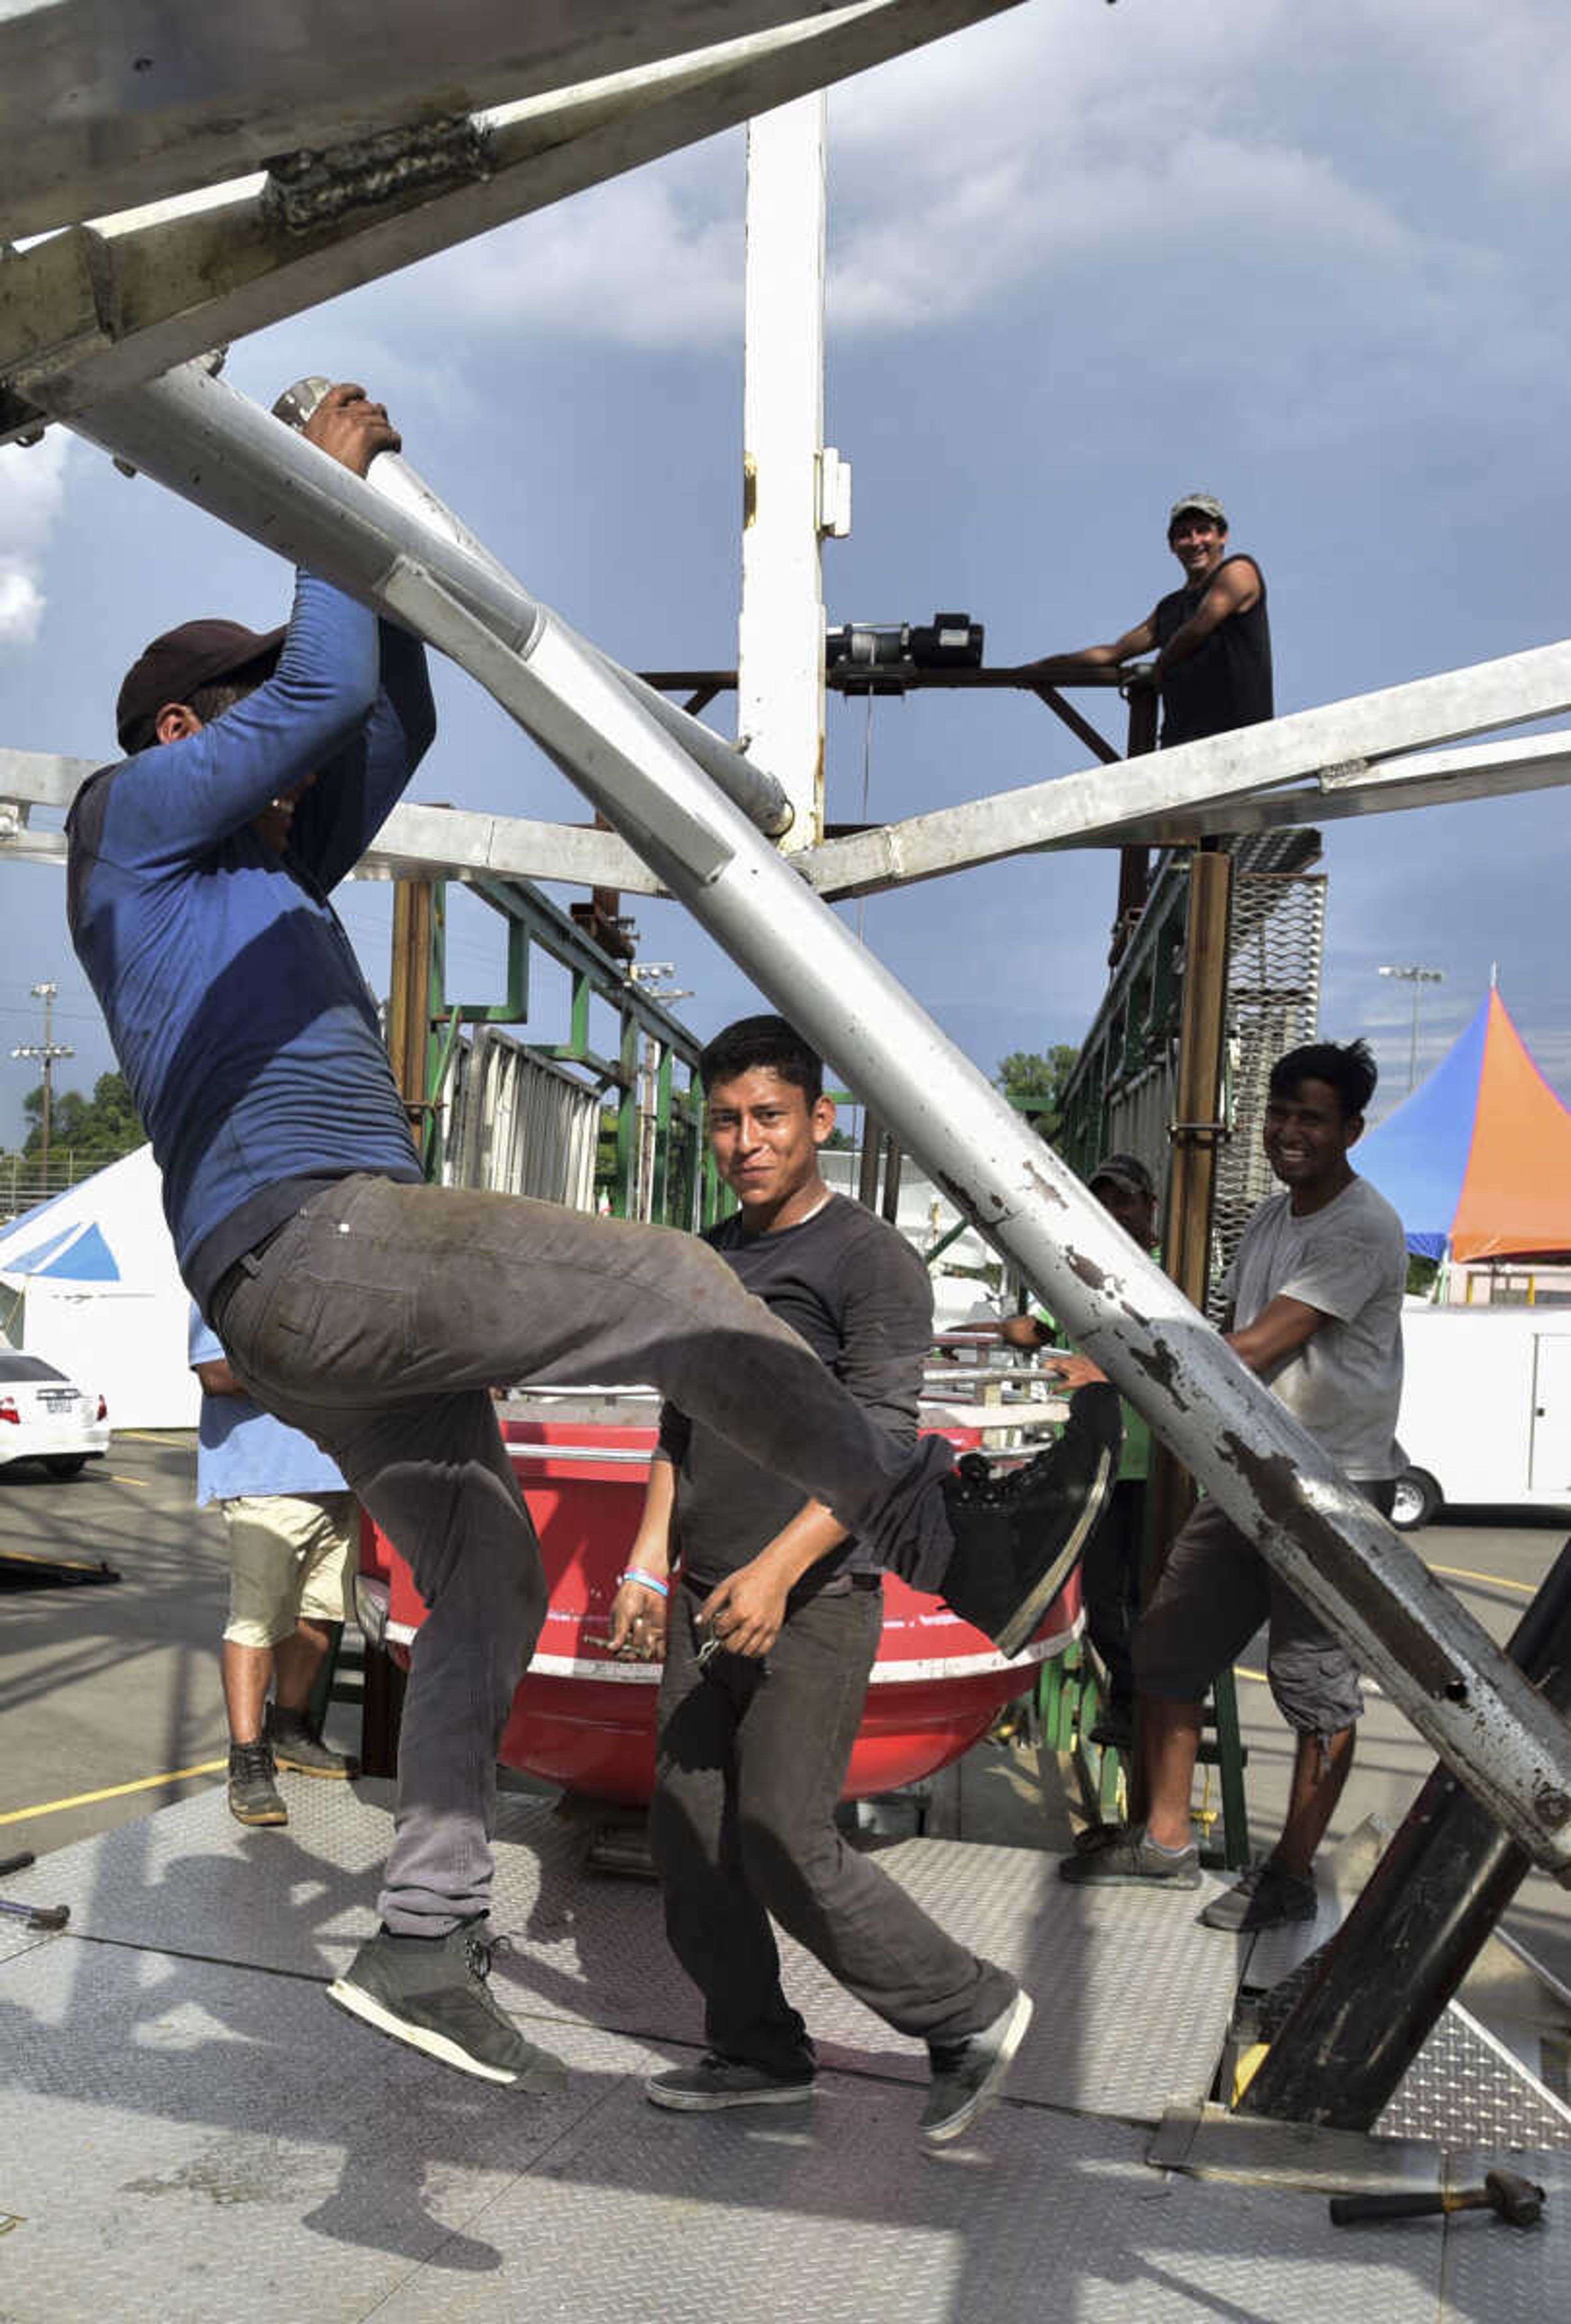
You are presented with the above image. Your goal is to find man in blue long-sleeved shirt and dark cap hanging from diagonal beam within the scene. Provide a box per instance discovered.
[68,386,1115,2089]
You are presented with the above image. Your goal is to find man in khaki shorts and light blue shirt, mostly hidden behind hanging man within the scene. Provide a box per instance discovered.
[191,1306,356,1824]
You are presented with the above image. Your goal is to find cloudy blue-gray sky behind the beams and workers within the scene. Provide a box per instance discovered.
[0,0,1571,1141]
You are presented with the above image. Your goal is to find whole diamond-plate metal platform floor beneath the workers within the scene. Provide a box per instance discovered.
[0,1785,1571,2324]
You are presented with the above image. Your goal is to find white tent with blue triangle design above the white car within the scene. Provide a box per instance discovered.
[0,1146,200,1429]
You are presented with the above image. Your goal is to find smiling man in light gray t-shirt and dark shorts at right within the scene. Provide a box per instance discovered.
[1060,1041,1406,1931]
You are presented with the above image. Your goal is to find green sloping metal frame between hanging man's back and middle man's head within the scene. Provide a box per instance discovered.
[409,879,730,1227]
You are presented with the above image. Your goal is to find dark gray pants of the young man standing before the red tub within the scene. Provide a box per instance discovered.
[648,1585,1015,2075]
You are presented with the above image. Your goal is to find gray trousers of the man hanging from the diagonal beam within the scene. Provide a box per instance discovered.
[212,1176,953,1933]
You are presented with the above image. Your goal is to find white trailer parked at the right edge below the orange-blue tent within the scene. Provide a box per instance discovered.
[1392,1306,1571,1529]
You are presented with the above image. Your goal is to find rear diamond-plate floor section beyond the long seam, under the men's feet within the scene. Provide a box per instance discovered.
[9,1782,1241,2122]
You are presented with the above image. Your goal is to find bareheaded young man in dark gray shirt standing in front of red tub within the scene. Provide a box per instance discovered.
[611,1016,1060,2143]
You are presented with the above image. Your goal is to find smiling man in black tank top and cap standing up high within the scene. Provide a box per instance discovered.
[1051,493,1274,751]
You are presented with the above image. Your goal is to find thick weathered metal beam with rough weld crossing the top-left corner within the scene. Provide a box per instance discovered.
[0,0,1018,442]
